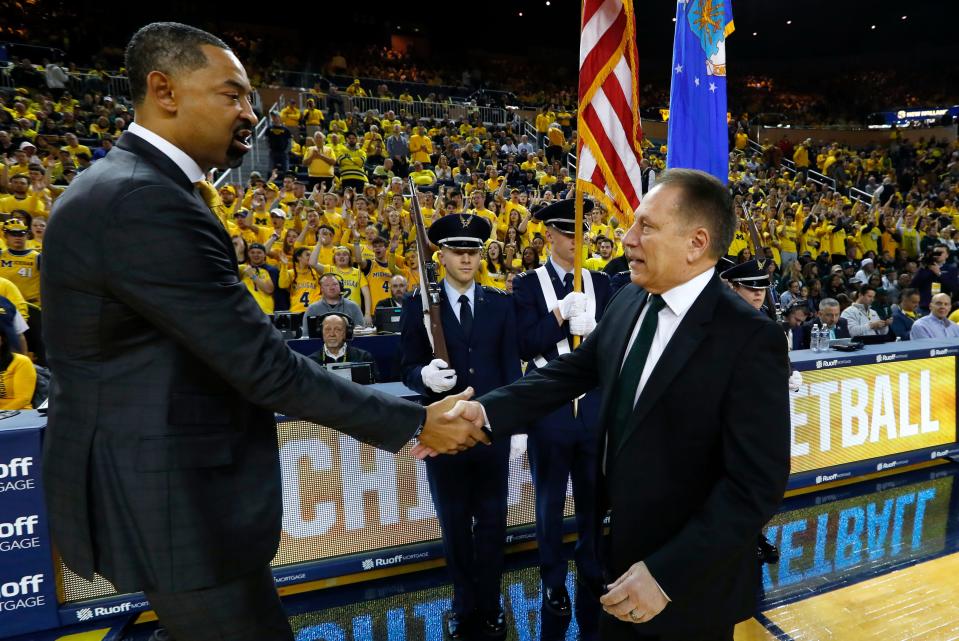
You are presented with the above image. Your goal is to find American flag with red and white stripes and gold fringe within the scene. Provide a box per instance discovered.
[576,0,643,222]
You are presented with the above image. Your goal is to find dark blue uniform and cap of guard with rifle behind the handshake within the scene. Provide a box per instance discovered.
[400,214,521,638]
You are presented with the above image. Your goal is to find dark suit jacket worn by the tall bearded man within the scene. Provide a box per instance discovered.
[42,133,424,591]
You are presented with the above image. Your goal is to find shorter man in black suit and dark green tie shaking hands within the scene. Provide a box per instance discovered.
[422,169,789,641]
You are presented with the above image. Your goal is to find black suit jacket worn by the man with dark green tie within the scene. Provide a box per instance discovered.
[480,276,789,634]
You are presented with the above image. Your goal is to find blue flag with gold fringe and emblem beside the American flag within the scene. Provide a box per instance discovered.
[666,0,733,185]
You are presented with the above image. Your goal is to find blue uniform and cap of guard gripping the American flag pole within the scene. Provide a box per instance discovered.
[513,200,610,640]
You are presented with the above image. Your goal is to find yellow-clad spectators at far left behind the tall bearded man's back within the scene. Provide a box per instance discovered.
[0,60,133,409]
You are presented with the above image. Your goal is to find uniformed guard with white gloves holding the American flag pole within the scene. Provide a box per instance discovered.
[513,198,610,641]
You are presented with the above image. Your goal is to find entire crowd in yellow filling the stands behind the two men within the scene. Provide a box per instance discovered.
[0,38,959,396]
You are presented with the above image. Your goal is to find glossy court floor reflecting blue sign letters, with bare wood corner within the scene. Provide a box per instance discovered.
[28,463,959,641]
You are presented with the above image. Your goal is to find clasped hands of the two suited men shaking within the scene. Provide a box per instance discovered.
[410,387,490,459]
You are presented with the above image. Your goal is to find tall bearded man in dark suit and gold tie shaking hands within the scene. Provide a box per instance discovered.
[43,23,486,641]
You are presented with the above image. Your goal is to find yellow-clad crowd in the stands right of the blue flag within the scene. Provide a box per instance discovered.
[729,130,959,340]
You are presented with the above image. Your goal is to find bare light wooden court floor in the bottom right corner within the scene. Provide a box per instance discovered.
[768,554,959,641]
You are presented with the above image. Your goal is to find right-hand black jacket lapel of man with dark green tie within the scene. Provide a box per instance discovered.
[613,276,723,456]
